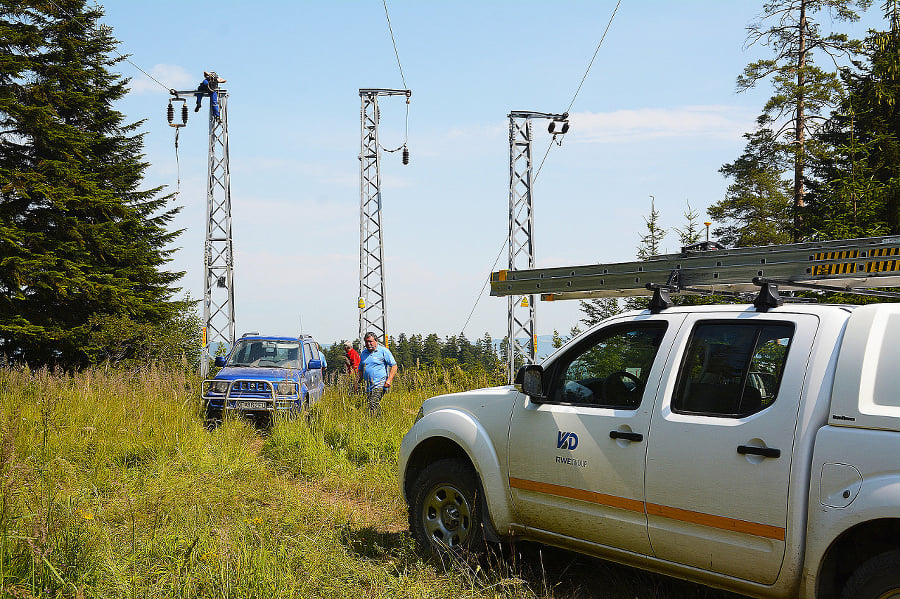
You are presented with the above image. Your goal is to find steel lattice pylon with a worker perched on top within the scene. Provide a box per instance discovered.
[200,90,234,377]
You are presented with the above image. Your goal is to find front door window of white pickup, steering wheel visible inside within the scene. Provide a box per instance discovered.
[548,322,667,410]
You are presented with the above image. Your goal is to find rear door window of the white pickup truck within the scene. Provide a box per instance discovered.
[672,321,794,418]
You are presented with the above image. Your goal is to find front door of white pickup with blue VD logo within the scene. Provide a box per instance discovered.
[508,314,684,554]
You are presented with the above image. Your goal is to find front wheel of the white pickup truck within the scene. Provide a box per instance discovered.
[409,459,484,555]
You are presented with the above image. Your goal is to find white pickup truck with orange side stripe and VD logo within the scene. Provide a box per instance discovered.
[400,304,900,599]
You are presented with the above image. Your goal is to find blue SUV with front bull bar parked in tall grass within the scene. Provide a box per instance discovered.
[201,333,325,421]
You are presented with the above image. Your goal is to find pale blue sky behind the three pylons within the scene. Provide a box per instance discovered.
[103,0,880,343]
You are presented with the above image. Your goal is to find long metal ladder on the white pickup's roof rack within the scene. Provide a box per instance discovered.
[491,236,900,309]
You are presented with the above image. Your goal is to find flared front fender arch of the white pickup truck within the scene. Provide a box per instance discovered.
[400,408,512,532]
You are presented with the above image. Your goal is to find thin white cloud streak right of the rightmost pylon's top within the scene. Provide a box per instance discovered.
[569,106,754,143]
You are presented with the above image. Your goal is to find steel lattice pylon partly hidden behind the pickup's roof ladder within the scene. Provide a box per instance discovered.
[507,111,568,383]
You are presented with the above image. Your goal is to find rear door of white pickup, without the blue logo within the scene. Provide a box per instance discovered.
[646,313,818,584]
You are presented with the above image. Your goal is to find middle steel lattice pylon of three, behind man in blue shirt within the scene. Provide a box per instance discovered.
[359,89,410,347]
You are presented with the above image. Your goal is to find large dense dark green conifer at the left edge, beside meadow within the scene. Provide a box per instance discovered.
[0,0,188,367]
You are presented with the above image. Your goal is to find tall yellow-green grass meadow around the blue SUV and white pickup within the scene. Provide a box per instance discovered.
[0,366,740,599]
